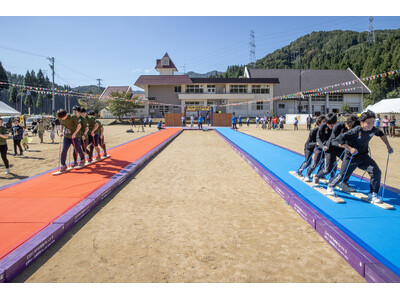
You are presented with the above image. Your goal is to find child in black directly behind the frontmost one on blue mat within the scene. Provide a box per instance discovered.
[315,116,360,193]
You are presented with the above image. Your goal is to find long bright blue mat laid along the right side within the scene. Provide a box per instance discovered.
[216,128,400,276]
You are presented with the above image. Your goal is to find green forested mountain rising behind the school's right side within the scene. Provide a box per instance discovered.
[217,29,400,103]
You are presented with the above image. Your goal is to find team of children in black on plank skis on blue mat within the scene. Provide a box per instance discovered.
[297,110,393,203]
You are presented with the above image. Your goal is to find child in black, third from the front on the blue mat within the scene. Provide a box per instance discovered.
[304,113,337,184]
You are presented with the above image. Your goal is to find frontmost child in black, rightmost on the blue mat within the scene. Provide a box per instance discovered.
[327,110,393,203]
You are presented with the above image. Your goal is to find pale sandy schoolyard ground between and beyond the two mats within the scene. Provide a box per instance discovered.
[0,126,378,283]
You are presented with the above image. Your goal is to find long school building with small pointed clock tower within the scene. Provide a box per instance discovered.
[135,53,371,117]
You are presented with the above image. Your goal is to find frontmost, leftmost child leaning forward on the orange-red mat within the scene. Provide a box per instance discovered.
[57,108,85,173]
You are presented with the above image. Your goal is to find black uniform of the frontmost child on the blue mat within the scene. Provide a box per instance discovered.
[329,125,385,193]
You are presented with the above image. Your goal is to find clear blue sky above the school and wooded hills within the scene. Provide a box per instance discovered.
[0,16,400,89]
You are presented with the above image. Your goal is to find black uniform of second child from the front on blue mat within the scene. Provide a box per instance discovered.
[316,122,347,178]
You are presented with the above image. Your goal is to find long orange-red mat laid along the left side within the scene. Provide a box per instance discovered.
[0,128,180,259]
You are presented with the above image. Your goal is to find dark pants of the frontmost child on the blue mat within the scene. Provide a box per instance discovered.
[329,152,382,193]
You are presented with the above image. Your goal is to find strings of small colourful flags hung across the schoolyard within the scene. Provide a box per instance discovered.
[0,70,399,107]
